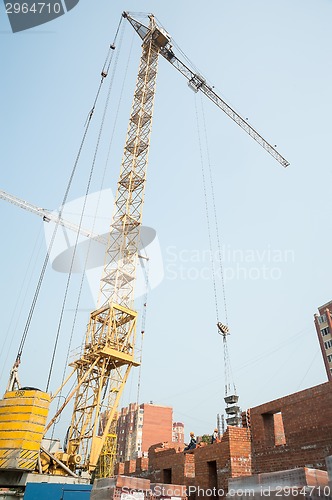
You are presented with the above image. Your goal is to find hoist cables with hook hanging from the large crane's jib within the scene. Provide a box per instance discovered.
[195,96,236,396]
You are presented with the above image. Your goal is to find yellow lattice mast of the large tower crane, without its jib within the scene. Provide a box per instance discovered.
[42,12,169,472]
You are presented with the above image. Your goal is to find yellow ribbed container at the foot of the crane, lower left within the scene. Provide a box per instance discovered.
[0,389,50,471]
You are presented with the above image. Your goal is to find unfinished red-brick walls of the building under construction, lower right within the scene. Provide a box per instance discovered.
[116,382,332,496]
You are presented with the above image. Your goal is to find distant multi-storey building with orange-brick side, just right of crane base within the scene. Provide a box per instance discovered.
[117,403,173,462]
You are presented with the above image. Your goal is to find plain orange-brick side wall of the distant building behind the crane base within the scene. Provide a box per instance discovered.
[141,404,173,452]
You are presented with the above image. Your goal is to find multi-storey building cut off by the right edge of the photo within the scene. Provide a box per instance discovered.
[314,301,332,381]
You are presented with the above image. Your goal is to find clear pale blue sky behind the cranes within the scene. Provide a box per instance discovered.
[0,0,332,442]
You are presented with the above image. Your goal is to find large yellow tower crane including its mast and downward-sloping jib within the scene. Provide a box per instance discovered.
[0,12,289,475]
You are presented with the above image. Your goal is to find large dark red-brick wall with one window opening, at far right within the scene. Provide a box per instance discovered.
[250,382,332,473]
